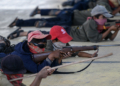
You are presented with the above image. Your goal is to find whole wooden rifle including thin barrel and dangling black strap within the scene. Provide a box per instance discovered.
[32,44,115,74]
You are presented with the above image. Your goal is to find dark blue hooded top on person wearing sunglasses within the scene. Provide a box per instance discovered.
[11,41,51,73]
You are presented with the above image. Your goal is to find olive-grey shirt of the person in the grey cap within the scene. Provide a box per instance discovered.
[70,19,102,42]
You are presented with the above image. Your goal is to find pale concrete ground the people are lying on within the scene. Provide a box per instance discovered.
[0,0,120,86]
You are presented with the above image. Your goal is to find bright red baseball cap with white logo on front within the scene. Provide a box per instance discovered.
[50,25,73,43]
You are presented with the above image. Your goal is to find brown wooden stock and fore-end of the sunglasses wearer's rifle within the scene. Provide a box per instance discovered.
[32,46,98,63]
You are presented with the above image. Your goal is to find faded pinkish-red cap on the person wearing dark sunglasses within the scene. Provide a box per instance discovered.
[28,30,51,42]
